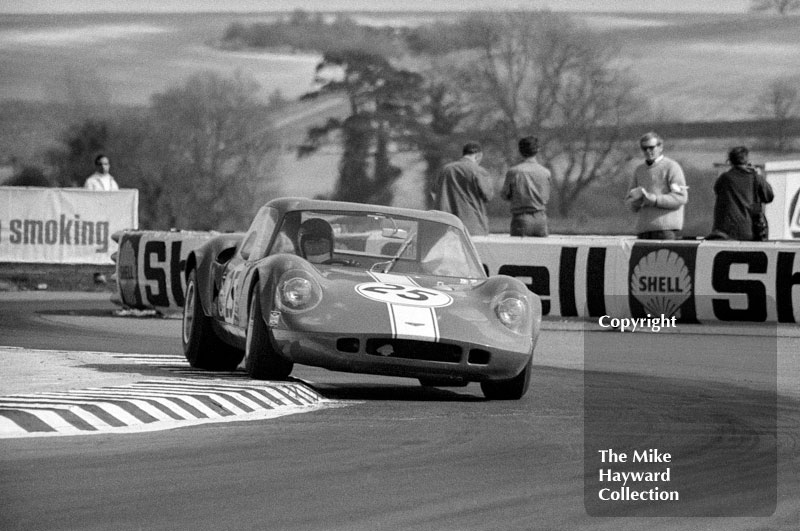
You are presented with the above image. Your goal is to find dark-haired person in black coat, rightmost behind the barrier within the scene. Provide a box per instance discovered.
[708,146,775,241]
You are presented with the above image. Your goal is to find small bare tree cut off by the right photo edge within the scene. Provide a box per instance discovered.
[754,76,800,152]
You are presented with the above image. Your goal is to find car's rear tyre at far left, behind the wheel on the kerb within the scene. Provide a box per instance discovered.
[181,269,242,371]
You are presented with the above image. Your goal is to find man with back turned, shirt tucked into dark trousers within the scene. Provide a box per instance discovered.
[500,136,551,237]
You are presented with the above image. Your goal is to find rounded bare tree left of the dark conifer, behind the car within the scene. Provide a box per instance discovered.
[147,72,276,230]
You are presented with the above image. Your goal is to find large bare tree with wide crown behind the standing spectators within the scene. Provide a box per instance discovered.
[460,12,643,215]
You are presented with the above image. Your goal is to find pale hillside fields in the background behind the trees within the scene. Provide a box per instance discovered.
[0,9,800,235]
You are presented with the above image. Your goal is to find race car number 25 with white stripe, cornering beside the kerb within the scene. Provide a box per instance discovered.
[182,198,541,400]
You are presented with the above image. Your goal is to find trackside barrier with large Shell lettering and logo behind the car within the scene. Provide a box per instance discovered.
[111,231,800,323]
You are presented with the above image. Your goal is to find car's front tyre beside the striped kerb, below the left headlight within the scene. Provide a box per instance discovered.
[244,286,294,380]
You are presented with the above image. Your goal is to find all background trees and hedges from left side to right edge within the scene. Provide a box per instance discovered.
[7,6,800,230]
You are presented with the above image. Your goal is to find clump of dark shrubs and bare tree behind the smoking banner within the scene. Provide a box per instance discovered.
[24,72,277,231]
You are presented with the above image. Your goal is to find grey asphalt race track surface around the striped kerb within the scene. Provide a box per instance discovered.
[0,295,800,530]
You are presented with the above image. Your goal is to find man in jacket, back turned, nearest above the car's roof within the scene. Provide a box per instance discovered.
[431,142,494,236]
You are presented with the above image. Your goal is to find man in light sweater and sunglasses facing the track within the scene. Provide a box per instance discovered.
[625,132,689,240]
